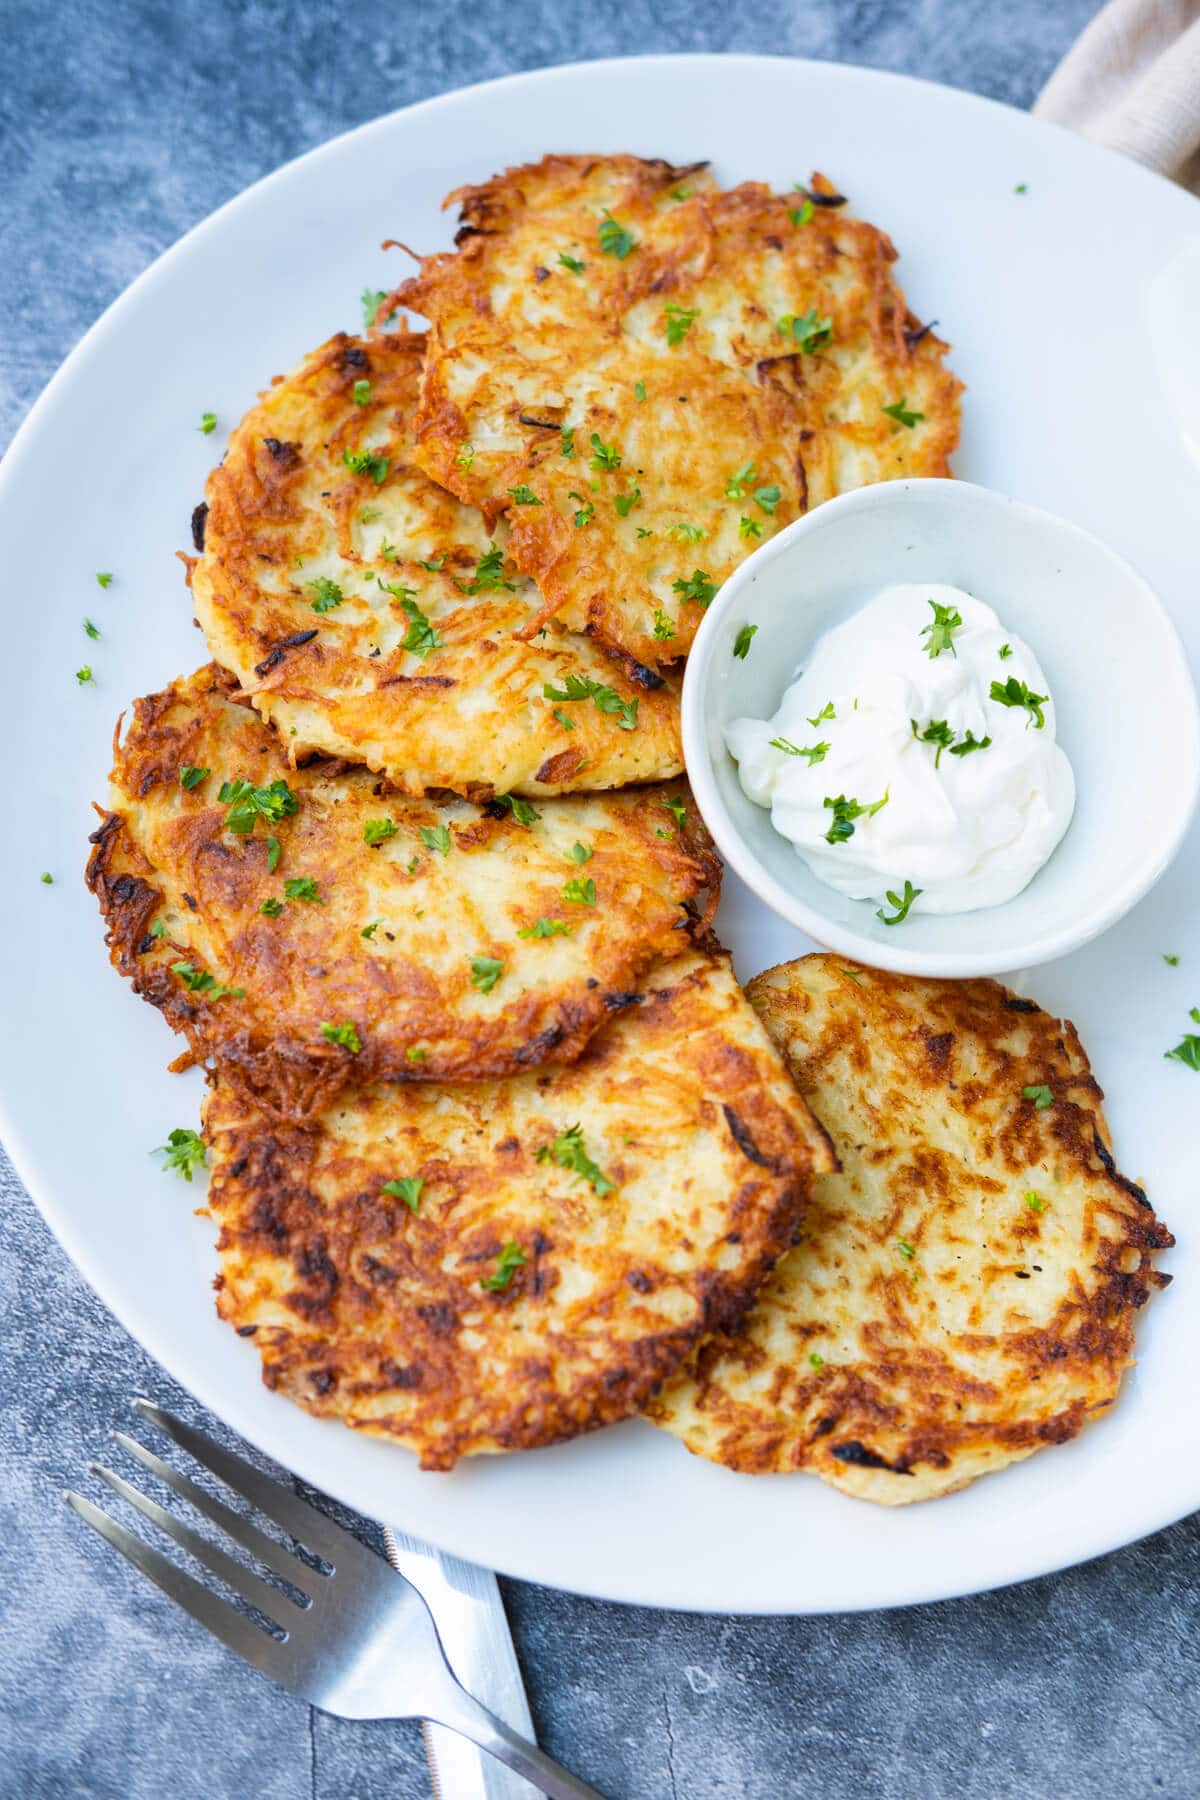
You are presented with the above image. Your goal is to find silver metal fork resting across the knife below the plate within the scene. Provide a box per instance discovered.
[63,1399,603,1800]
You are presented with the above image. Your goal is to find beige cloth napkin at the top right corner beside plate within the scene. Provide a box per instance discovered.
[1033,0,1200,194]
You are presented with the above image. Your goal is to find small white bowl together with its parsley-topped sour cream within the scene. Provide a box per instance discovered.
[682,481,1200,976]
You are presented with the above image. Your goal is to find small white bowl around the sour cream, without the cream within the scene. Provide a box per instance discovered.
[684,481,1200,976]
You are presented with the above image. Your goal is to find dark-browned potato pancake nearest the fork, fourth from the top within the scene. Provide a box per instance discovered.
[205,952,831,1469]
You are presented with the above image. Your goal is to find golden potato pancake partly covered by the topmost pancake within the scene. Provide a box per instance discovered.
[191,331,684,799]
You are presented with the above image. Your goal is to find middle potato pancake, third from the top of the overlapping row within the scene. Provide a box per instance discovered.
[88,666,720,1116]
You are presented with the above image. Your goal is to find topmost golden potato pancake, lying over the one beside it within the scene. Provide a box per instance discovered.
[394,157,961,664]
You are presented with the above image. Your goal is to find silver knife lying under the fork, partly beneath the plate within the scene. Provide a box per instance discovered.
[383,1525,542,1800]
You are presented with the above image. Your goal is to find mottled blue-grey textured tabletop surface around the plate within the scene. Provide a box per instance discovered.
[0,0,1200,1800]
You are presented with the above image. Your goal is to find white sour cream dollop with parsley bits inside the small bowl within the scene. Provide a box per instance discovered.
[725,583,1076,913]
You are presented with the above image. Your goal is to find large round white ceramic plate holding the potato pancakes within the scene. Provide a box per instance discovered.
[0,58,1200,1613]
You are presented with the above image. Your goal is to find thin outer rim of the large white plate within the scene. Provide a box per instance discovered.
[0,52,1200,1616]
